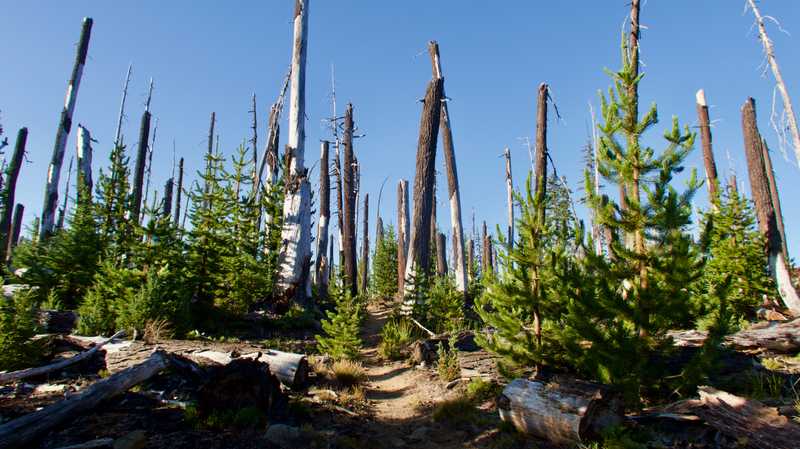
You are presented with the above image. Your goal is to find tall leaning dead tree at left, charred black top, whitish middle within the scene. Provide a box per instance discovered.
[39,17,93,240]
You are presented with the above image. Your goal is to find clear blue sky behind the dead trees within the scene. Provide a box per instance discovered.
[0,0,800,257]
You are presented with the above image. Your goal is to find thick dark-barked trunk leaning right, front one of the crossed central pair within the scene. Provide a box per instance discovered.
[404,78,443,300]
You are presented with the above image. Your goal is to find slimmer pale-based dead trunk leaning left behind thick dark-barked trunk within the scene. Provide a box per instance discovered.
[428,41,467,292]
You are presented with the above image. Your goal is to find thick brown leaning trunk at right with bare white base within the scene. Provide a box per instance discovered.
[742,98,800,315]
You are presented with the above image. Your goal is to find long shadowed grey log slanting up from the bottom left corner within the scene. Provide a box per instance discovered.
[0,350,169,448]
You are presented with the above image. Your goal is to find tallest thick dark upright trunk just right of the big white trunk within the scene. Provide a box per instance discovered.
[342,104,358,296]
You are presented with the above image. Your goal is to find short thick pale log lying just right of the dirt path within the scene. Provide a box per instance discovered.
[497,379,623,445]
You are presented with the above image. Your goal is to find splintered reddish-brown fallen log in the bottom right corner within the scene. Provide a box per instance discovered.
[665,386,800,449]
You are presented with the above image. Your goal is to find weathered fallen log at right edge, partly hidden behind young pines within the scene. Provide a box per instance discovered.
[668,318,800,354]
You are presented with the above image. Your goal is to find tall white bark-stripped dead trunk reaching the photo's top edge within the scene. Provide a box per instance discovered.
[278,0,311,303]
